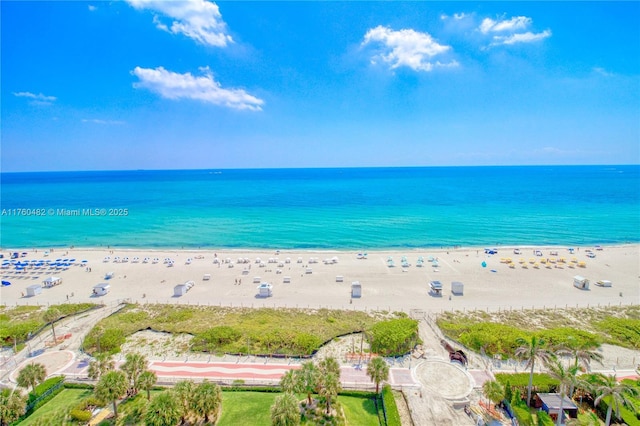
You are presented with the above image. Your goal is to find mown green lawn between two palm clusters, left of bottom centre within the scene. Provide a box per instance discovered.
[218,392,279,426]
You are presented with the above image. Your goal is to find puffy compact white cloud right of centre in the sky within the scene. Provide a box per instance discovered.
[362,25,458,71]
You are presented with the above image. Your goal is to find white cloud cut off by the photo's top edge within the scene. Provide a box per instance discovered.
[127,0,233,47]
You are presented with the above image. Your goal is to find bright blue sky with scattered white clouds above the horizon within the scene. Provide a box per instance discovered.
[0,0,640,172]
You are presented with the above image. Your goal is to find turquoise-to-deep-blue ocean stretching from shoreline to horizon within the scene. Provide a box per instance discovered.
[0,165,640,250]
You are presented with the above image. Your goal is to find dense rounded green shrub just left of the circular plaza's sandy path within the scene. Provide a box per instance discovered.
[370,318,420,356]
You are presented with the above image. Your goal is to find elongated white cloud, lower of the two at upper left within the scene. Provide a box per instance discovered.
[132,67,264,111]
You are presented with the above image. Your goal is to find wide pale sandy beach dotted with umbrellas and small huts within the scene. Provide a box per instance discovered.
[0,244,640,312]
